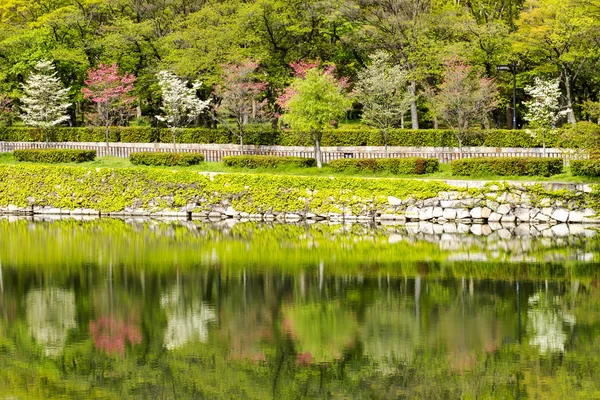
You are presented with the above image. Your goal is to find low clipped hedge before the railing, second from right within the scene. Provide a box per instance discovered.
[452,157,563,176]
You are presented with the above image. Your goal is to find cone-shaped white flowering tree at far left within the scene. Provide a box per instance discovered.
[21,60,71,143]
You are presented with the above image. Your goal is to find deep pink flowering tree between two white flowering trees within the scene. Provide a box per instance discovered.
[81,64,135,146]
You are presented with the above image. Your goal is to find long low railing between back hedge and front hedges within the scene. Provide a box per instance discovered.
[0,142,587,165]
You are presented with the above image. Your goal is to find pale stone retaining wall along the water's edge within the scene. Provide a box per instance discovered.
[0,180,600,225]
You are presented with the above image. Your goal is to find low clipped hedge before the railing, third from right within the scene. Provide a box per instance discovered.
[329,157,440,175]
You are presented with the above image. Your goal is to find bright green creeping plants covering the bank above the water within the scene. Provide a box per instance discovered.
[0,165,449,214]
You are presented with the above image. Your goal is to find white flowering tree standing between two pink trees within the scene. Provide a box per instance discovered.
[156,71,210,148]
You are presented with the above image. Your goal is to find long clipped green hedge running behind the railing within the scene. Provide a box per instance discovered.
[0,127,579,147]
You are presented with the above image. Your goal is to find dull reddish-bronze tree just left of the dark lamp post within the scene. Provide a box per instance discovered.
[432,59,498,158]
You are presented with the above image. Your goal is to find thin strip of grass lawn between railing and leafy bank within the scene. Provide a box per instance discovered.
[0,153,600,183]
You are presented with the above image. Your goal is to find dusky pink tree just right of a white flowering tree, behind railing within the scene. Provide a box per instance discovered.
[215,59,268,146]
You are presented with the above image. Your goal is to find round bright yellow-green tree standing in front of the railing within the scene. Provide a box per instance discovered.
[279,68,352,168]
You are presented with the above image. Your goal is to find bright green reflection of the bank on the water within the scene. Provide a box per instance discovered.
[0,219,598,280]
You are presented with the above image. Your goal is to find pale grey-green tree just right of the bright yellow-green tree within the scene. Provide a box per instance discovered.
[354,51,413,156]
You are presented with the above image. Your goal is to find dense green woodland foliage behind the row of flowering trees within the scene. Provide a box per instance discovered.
[0,0,600,136]
